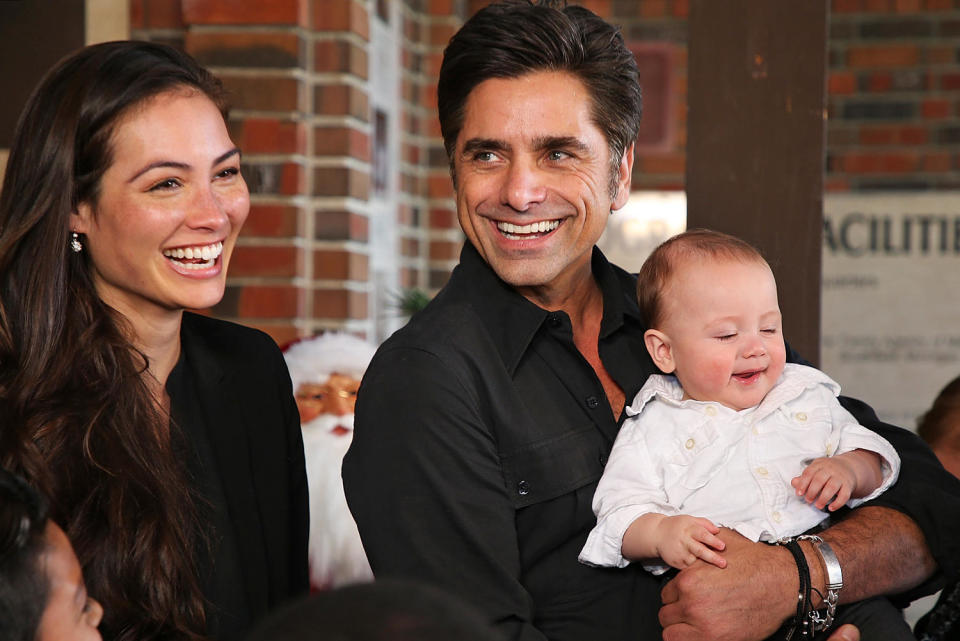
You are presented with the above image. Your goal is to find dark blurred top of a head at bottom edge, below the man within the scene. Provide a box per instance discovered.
[246,580,503,641]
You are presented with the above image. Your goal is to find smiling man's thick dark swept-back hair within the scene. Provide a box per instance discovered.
[437,0,641,167]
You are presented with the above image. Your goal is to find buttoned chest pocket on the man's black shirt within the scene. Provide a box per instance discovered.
[500,424,604,508]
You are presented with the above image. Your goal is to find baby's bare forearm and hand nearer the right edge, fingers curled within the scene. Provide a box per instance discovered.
[790,449,883,512]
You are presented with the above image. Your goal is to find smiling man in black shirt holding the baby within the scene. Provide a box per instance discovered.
[343,2,960,641]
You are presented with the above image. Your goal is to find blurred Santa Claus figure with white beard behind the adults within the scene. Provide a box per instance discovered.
[284,333,376,589]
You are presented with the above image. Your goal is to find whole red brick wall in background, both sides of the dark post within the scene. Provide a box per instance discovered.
[130,0,960,343]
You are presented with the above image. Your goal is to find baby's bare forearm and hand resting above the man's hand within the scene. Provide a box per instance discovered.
[620,512,727,570]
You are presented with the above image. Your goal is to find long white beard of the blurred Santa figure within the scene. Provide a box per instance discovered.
[302,414,373,588]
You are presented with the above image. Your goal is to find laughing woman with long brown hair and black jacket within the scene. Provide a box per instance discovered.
[0,42,308,641]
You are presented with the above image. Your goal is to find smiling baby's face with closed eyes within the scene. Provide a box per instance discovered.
[661,260,786,410]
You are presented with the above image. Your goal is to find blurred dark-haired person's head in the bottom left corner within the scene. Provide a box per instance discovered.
[0,468,103,641]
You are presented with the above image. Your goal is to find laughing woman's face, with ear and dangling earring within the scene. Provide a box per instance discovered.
[70,88,250,319]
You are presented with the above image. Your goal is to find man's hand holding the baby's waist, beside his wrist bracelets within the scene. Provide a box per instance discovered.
[660,528,800,641]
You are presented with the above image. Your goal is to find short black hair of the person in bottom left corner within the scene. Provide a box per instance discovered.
[0,468,50,641]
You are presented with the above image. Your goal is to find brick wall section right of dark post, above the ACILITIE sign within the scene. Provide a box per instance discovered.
[826,0,960,191]
